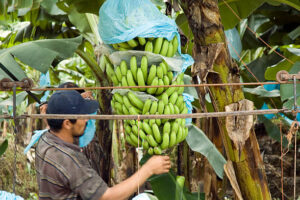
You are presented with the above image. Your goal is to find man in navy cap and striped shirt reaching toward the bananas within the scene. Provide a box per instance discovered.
[36,90,171,200]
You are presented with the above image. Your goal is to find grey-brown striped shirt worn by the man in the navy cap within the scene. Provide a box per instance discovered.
[35,132,107,200]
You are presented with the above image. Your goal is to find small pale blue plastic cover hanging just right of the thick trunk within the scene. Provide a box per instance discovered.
[225,28,242,60]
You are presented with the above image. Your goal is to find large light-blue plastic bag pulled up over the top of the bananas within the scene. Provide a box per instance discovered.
[98,0,194,72]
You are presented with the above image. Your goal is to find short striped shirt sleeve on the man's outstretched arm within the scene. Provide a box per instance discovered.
[69,153,107,200]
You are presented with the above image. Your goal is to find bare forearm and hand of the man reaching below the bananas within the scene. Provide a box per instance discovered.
[99,156,171,200]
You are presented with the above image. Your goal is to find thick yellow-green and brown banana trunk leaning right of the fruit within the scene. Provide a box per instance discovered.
[181,0,271,200]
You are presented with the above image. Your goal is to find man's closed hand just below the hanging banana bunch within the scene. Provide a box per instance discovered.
[145,156,171,174]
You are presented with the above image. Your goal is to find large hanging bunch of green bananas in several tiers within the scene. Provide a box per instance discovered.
[108,37,188,155]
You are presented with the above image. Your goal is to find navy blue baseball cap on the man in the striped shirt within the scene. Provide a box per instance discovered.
[47,90,99,114]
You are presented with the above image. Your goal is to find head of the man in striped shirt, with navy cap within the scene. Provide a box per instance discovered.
[46,90,99,136]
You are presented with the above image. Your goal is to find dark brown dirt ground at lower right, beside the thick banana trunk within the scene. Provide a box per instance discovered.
[256,122,300,199]
